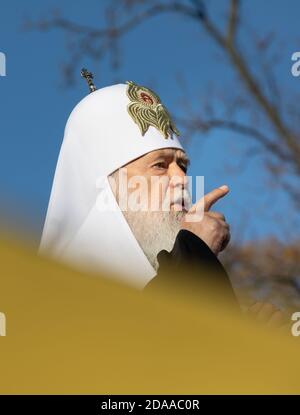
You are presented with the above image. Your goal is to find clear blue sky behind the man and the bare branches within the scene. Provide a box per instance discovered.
[0,0,300,245]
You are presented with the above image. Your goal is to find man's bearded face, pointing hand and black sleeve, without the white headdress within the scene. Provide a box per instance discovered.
[110,148,233,297]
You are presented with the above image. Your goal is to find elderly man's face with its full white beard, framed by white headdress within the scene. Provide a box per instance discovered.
[109,148,190,269]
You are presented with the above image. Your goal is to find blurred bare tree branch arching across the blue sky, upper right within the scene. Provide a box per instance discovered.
[31,0,300,203]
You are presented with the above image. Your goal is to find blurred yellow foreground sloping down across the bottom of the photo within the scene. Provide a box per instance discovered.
[0,232,300,394]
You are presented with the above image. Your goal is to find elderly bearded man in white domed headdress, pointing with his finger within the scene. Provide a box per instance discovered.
[40,79,231,304]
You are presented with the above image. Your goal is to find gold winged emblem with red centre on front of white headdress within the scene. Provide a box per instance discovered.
[126,81,179,139]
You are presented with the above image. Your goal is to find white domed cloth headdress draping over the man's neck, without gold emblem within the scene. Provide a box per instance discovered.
[39,84,182,288]
